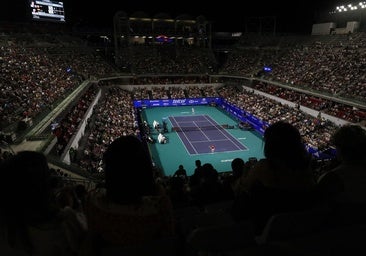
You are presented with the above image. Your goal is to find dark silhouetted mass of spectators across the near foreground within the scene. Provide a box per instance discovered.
[0,121,366,256]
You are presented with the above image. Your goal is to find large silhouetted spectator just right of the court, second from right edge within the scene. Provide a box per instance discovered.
[232,121,319,232]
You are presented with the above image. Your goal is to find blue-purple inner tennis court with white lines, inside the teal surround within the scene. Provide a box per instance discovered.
[169,115,248,155]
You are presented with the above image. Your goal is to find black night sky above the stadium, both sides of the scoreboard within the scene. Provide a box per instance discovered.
[0,0,347,32]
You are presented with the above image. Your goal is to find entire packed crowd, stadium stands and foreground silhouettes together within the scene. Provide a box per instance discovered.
[0,25,366,256]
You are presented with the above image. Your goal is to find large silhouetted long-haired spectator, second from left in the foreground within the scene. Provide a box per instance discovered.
[86,135,174,250]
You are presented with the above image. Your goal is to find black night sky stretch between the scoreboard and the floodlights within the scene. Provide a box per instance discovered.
[65,0,329,31]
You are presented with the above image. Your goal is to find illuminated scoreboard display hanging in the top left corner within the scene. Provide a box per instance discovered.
[29,0,65,22]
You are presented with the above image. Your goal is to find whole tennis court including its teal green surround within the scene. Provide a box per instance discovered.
[142,106,263,176]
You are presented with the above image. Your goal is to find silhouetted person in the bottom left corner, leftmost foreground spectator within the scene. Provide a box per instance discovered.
[0,151,86,256]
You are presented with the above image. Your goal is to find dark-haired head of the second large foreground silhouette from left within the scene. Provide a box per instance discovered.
[103,135,155,204]
